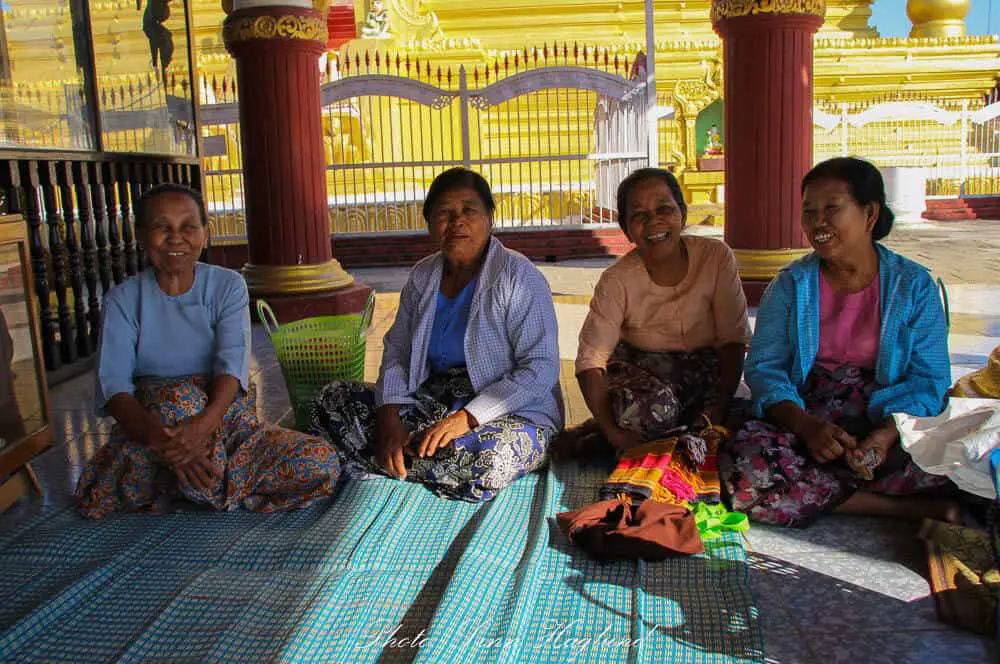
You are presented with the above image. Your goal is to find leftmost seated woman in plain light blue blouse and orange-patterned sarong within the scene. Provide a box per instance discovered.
[77,184,340,517]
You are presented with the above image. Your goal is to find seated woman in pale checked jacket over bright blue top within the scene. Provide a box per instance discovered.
[312,168,563,501]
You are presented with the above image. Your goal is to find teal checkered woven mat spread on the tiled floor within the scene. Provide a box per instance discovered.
[0,465,763,664]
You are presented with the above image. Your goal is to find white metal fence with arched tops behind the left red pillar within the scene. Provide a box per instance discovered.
[201,56,650,242]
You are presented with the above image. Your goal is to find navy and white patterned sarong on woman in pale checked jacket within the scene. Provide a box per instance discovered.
[310,368,554,502]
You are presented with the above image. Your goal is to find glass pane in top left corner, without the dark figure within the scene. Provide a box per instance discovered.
[0,0,94,150]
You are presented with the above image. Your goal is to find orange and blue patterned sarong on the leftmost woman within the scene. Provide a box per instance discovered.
[76,376,340,517]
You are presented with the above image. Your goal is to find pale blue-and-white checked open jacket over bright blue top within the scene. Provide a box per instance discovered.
[375,237,563,432]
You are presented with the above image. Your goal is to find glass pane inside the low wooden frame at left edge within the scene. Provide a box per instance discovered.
[0,244,45,447]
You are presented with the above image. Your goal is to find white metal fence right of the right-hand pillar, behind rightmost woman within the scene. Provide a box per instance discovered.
[813,90,1000,196]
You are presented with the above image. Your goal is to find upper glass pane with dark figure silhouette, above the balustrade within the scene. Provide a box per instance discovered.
[97,0,195,156]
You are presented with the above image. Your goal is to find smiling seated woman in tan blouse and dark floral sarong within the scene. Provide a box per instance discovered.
[559,168,750,456]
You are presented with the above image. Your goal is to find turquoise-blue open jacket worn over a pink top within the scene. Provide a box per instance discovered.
[746,244,951,422]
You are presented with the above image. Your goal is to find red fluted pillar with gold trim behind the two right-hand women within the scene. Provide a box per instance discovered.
[712,0,826,302]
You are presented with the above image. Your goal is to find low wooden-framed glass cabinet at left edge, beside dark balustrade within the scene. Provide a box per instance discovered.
[0,215,52,512]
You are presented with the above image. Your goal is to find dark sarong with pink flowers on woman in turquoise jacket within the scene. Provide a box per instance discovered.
[720,365,950,526]
